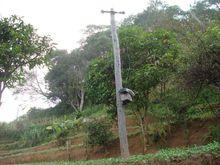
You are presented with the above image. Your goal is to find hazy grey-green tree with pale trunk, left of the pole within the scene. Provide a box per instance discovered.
[46,25,111,110]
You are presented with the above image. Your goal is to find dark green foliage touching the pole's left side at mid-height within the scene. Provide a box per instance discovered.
[86,54,116,106]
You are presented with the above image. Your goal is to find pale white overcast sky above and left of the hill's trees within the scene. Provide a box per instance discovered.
[0,0,195,122]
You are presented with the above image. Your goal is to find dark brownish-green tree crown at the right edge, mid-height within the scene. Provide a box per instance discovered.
[183,24,220,89]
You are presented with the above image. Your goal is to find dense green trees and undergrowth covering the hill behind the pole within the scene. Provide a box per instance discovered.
[0,0,220,163]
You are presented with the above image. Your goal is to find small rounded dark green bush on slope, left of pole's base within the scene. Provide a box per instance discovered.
[86,119,113,147]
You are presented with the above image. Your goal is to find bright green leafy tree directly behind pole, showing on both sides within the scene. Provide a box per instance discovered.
[86,26,179,151]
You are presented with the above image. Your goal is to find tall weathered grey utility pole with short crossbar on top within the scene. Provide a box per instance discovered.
[101,9,129,158]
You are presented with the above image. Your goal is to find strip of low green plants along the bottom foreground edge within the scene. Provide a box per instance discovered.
[19,142,220,165]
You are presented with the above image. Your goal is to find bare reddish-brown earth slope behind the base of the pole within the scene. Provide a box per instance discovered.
[0,114,220,164]
